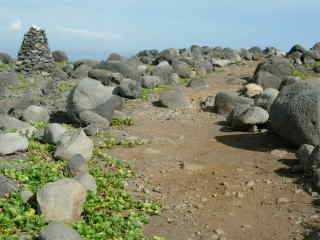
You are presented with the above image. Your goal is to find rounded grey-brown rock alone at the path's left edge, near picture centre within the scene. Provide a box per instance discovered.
[159,88,191,109]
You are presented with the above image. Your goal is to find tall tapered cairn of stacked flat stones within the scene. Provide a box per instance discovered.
[16,26,54,74]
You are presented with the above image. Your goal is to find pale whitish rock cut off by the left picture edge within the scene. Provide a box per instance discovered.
[0,133,29,155]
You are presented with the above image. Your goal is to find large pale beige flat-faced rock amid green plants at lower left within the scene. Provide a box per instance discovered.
[37,178,86,222]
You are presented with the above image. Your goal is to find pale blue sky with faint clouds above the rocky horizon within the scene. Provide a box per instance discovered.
[0,0,320,59]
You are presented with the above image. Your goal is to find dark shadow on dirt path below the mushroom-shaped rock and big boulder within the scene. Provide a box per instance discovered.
[216,132,290,152]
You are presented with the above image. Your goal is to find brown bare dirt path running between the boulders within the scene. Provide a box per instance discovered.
[111,63,319,240]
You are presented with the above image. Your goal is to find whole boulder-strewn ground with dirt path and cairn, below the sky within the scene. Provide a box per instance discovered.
[0,27,320,240]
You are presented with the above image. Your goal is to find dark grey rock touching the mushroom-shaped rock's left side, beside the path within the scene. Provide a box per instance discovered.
[215,92,254,114]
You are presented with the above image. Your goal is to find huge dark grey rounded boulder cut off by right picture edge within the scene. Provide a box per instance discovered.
[270,79,320,146]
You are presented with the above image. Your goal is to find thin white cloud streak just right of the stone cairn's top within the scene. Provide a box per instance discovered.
[58,27,122,40]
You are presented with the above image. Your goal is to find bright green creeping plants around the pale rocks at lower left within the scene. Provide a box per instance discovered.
[0,140,161,240]
